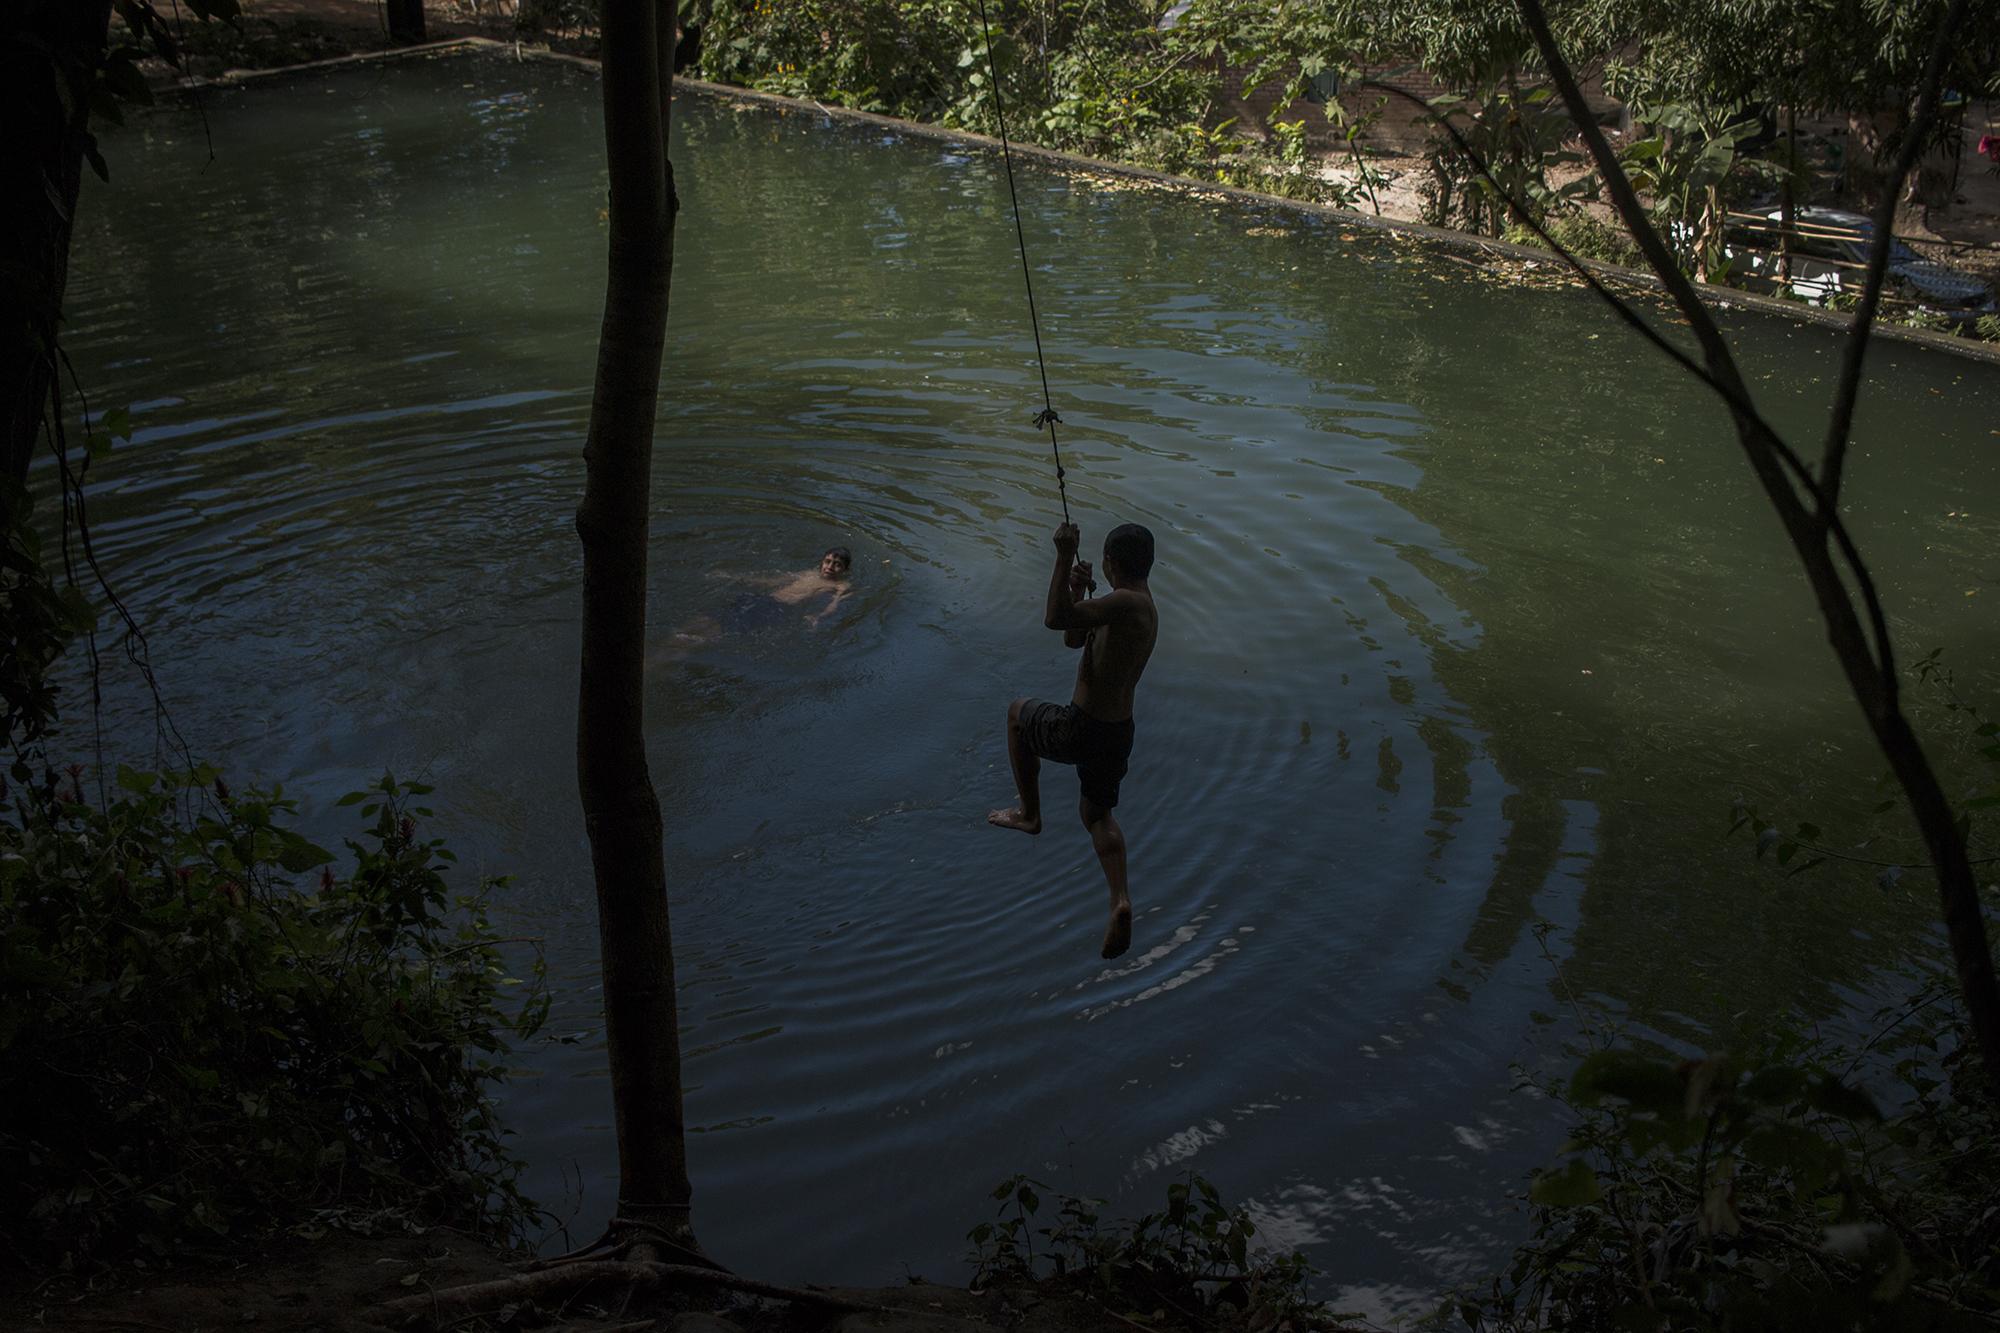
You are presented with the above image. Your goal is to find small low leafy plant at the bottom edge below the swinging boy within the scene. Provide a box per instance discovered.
[966,1173,1316,1327]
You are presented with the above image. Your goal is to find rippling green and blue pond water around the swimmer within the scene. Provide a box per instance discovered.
[68,49,2000,1313]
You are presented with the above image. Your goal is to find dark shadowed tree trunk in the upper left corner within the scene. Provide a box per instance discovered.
[0,0,112,516]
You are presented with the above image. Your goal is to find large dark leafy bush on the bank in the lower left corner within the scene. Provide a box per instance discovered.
[0,767,548,1263]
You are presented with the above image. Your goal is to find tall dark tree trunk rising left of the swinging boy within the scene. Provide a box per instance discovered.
[576,0,692,1243]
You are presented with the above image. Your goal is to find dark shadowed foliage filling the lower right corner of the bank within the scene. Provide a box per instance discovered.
[1440,987,2000,1333]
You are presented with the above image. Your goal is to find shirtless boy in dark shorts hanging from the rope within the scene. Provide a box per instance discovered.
[986,522,1160,959]
